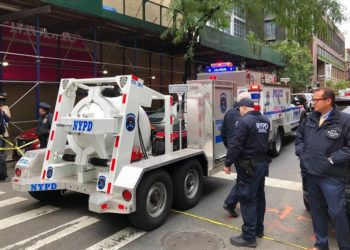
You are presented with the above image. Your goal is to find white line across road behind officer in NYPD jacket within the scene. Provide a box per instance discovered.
[212,171,303,191]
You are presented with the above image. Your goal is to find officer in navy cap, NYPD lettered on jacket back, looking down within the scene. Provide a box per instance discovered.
[224,98,270,247]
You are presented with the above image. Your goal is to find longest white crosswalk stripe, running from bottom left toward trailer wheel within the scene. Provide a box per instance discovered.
[2,216,99,250]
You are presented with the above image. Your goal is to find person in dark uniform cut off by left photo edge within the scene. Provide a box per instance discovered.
[0,95,11,181]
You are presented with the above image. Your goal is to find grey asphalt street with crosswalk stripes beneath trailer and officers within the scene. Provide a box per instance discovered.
[0,138,342,250]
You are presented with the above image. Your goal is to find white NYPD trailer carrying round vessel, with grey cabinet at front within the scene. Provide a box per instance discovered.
[12,75,233,230]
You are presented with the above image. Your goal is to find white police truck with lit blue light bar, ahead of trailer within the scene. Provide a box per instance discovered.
[197,63,305,156]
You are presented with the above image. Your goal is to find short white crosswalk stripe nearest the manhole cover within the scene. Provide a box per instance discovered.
[87,227,147,250]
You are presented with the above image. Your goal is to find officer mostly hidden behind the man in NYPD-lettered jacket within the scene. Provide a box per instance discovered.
[221,92,250,218]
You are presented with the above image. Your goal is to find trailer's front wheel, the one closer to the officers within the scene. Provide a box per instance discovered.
[173,159,203,210]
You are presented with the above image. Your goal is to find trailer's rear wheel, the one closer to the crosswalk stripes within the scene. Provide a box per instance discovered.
[129,171,174,231]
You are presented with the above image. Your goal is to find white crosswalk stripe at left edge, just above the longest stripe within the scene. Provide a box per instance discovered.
[0,206,60,230]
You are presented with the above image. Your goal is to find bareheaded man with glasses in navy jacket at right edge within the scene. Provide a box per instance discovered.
[295,88,350,250]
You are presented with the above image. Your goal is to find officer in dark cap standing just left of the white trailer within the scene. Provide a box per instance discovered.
[35,102,52,148]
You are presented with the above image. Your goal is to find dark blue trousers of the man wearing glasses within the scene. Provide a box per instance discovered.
[306,174,350,250]
